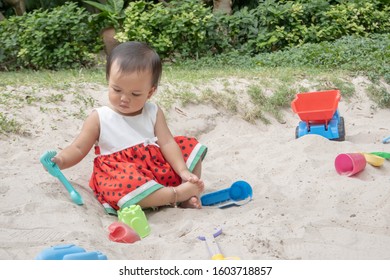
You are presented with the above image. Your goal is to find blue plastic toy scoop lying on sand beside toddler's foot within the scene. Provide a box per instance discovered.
[200,181,252,208]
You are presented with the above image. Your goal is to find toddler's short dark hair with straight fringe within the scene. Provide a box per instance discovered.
[106,41,162,87]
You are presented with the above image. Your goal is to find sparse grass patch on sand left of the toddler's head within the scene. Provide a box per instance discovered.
[0,68,105,135]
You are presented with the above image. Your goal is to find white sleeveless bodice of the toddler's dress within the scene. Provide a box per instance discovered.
[95,102,158,155]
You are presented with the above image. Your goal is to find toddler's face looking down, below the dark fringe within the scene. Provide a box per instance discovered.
[108,62,156,116]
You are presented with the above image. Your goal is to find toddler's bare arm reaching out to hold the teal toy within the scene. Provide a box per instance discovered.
[52,111,100,169]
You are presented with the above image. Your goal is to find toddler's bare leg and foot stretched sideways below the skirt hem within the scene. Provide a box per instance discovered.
[138,181,204,208]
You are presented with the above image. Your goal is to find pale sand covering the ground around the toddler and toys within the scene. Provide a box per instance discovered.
[0,76,390,260]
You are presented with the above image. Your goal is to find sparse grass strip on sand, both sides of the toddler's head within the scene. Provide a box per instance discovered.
[0,65,390,137]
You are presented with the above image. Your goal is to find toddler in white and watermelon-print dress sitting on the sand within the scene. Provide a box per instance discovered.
[48,42,207,214]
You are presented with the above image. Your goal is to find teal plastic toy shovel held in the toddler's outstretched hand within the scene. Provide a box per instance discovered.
[40,151,84,205]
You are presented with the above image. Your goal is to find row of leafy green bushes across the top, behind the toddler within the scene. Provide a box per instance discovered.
[0,0,390,72]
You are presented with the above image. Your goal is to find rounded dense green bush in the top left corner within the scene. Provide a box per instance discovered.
[0,3,98,70]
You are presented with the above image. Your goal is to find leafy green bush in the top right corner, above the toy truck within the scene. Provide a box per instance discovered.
[248,0,390,53]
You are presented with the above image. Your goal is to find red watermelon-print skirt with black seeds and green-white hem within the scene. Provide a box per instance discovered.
[89,136,207,215]
